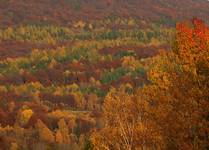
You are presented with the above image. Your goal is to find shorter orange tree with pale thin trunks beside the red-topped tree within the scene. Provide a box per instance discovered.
[91,88,163,150]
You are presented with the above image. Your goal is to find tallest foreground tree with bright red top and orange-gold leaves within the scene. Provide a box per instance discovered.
[146,19,209,149]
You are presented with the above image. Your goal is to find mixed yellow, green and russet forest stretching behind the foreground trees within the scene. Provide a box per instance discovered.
[0,17,175,149]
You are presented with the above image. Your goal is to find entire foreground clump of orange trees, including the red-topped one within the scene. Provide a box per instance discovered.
[91,19,209,150]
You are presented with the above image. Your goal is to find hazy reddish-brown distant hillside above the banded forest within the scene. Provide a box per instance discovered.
[0,0,209,26]
